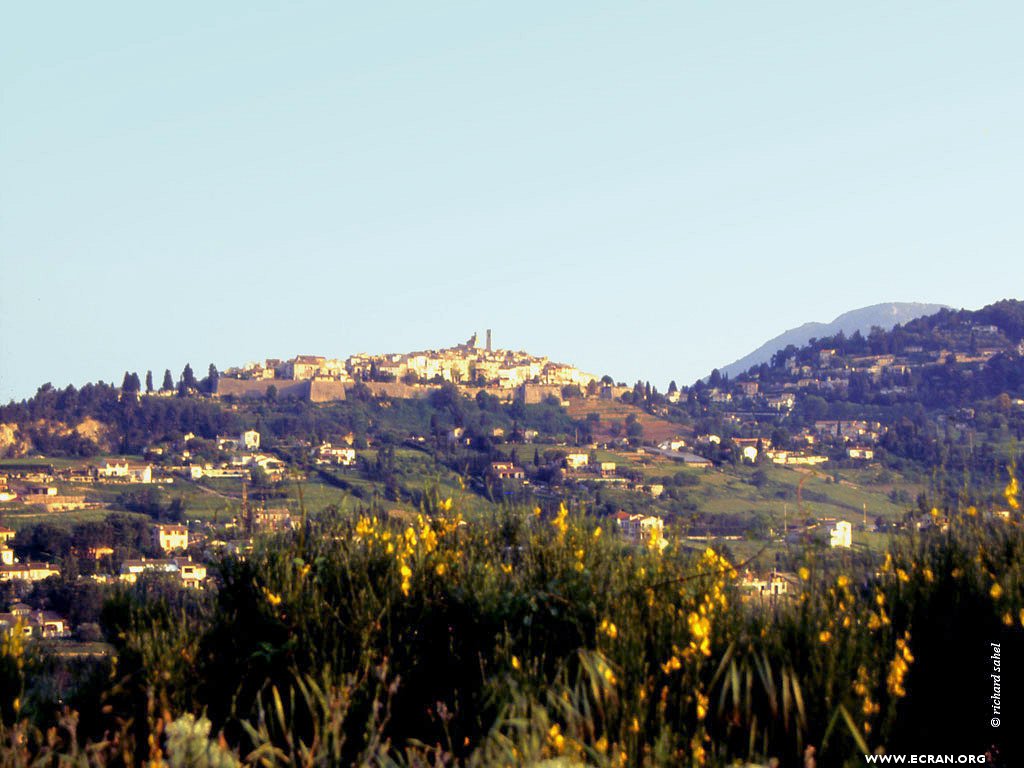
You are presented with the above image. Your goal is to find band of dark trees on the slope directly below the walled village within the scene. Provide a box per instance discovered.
[0,382,588,456]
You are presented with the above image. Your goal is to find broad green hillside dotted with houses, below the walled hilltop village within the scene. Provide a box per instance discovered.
[0,301,1024,538]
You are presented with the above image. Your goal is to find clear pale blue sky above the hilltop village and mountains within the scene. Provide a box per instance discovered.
[0,0,1024,401]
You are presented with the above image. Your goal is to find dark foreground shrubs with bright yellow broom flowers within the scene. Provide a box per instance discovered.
[0,479,1024,766]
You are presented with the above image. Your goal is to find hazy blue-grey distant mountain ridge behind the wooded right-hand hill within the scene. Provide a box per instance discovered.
[721,301,949,378]
